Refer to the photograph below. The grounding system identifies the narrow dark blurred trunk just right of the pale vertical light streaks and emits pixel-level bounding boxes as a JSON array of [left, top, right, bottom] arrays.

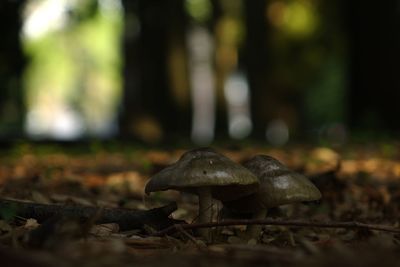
[[244, 0, 268, 137]]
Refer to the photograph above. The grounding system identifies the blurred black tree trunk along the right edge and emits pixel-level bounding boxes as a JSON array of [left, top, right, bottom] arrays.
[[347, 0, 400, 132]]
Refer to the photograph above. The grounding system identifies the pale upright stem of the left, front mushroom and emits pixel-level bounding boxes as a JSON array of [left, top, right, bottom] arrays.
[[197, 187, 212, 241]]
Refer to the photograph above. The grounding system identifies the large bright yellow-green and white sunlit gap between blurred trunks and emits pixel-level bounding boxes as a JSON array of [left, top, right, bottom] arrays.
[[22, 0, 122, 139]]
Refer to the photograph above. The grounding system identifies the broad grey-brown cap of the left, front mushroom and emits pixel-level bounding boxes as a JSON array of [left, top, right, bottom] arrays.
[[145, 148, 259, 201]]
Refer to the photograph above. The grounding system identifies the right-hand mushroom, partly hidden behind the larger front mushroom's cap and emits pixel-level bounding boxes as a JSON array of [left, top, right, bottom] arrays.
[[223, 155, 321, 238]]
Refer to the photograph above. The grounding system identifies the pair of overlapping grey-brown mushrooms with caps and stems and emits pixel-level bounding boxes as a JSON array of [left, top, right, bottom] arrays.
[[145, 148, 321, 240]]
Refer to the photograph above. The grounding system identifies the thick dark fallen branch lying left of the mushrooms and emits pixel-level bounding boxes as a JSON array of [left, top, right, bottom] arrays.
[[0, 199, 180, 231]]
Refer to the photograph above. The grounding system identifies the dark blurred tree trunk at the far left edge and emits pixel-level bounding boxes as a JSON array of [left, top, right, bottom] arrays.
[[0, 0, 25, 138]]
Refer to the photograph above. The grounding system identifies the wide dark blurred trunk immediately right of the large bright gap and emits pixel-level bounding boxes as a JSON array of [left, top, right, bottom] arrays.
[[120, 0, 182, 141]]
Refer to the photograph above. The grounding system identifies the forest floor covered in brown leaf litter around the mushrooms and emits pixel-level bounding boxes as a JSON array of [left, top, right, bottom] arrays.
[[0, 143, 400, 267]]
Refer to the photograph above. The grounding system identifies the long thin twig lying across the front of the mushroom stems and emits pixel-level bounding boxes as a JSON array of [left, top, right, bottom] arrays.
[[153, 219, 400, 236]]
